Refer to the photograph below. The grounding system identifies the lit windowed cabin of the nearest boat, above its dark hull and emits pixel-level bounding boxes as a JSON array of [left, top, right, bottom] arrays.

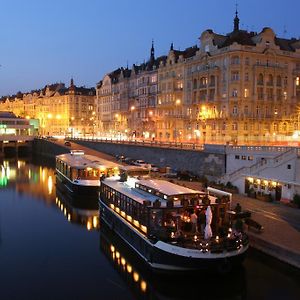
[[100, 177, 229, 241]]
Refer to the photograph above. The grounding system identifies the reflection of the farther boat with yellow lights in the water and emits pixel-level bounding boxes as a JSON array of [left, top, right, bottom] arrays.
[[55, 180, 99, 231]]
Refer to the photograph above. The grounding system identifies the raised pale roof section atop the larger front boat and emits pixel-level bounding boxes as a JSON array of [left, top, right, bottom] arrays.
[[138, 179, 203, 196]]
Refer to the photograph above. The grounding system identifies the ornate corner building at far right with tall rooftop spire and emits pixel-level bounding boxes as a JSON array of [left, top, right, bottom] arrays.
[[185, 13, 300, 143]]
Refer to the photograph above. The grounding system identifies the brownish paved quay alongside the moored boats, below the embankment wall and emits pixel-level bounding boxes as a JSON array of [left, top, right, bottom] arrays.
[[32, 140, 300, 269]]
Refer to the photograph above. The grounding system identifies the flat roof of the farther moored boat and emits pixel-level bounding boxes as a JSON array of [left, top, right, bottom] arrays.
[[56, 153, 119, 169]]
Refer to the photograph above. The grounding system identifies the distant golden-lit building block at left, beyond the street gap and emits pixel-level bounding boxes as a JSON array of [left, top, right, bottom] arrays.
[[0, 79, 97, 136]]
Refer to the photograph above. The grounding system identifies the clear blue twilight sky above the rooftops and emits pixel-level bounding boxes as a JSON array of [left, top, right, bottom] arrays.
[[0, 0, 300, 96]]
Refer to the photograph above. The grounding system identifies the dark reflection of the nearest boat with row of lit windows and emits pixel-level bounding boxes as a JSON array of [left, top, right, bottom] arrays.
[[100, 223, 247, 299]]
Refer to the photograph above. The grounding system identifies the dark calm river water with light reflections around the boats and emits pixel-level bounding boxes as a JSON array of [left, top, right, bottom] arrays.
[[0, 159, 300, 299]]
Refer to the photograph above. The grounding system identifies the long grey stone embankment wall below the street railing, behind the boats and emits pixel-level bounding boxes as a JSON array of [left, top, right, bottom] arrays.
[[69, 140, 225, 179]]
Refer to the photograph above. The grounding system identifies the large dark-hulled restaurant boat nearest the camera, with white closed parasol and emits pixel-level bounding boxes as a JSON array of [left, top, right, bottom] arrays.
[[99, 176, 249, 272]]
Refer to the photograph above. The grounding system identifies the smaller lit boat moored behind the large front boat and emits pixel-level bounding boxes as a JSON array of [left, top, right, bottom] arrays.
[[56, 150, 119, 196]]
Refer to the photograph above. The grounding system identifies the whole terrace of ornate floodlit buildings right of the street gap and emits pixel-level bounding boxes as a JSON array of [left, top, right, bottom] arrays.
[[97, 12, 300, 144]]
